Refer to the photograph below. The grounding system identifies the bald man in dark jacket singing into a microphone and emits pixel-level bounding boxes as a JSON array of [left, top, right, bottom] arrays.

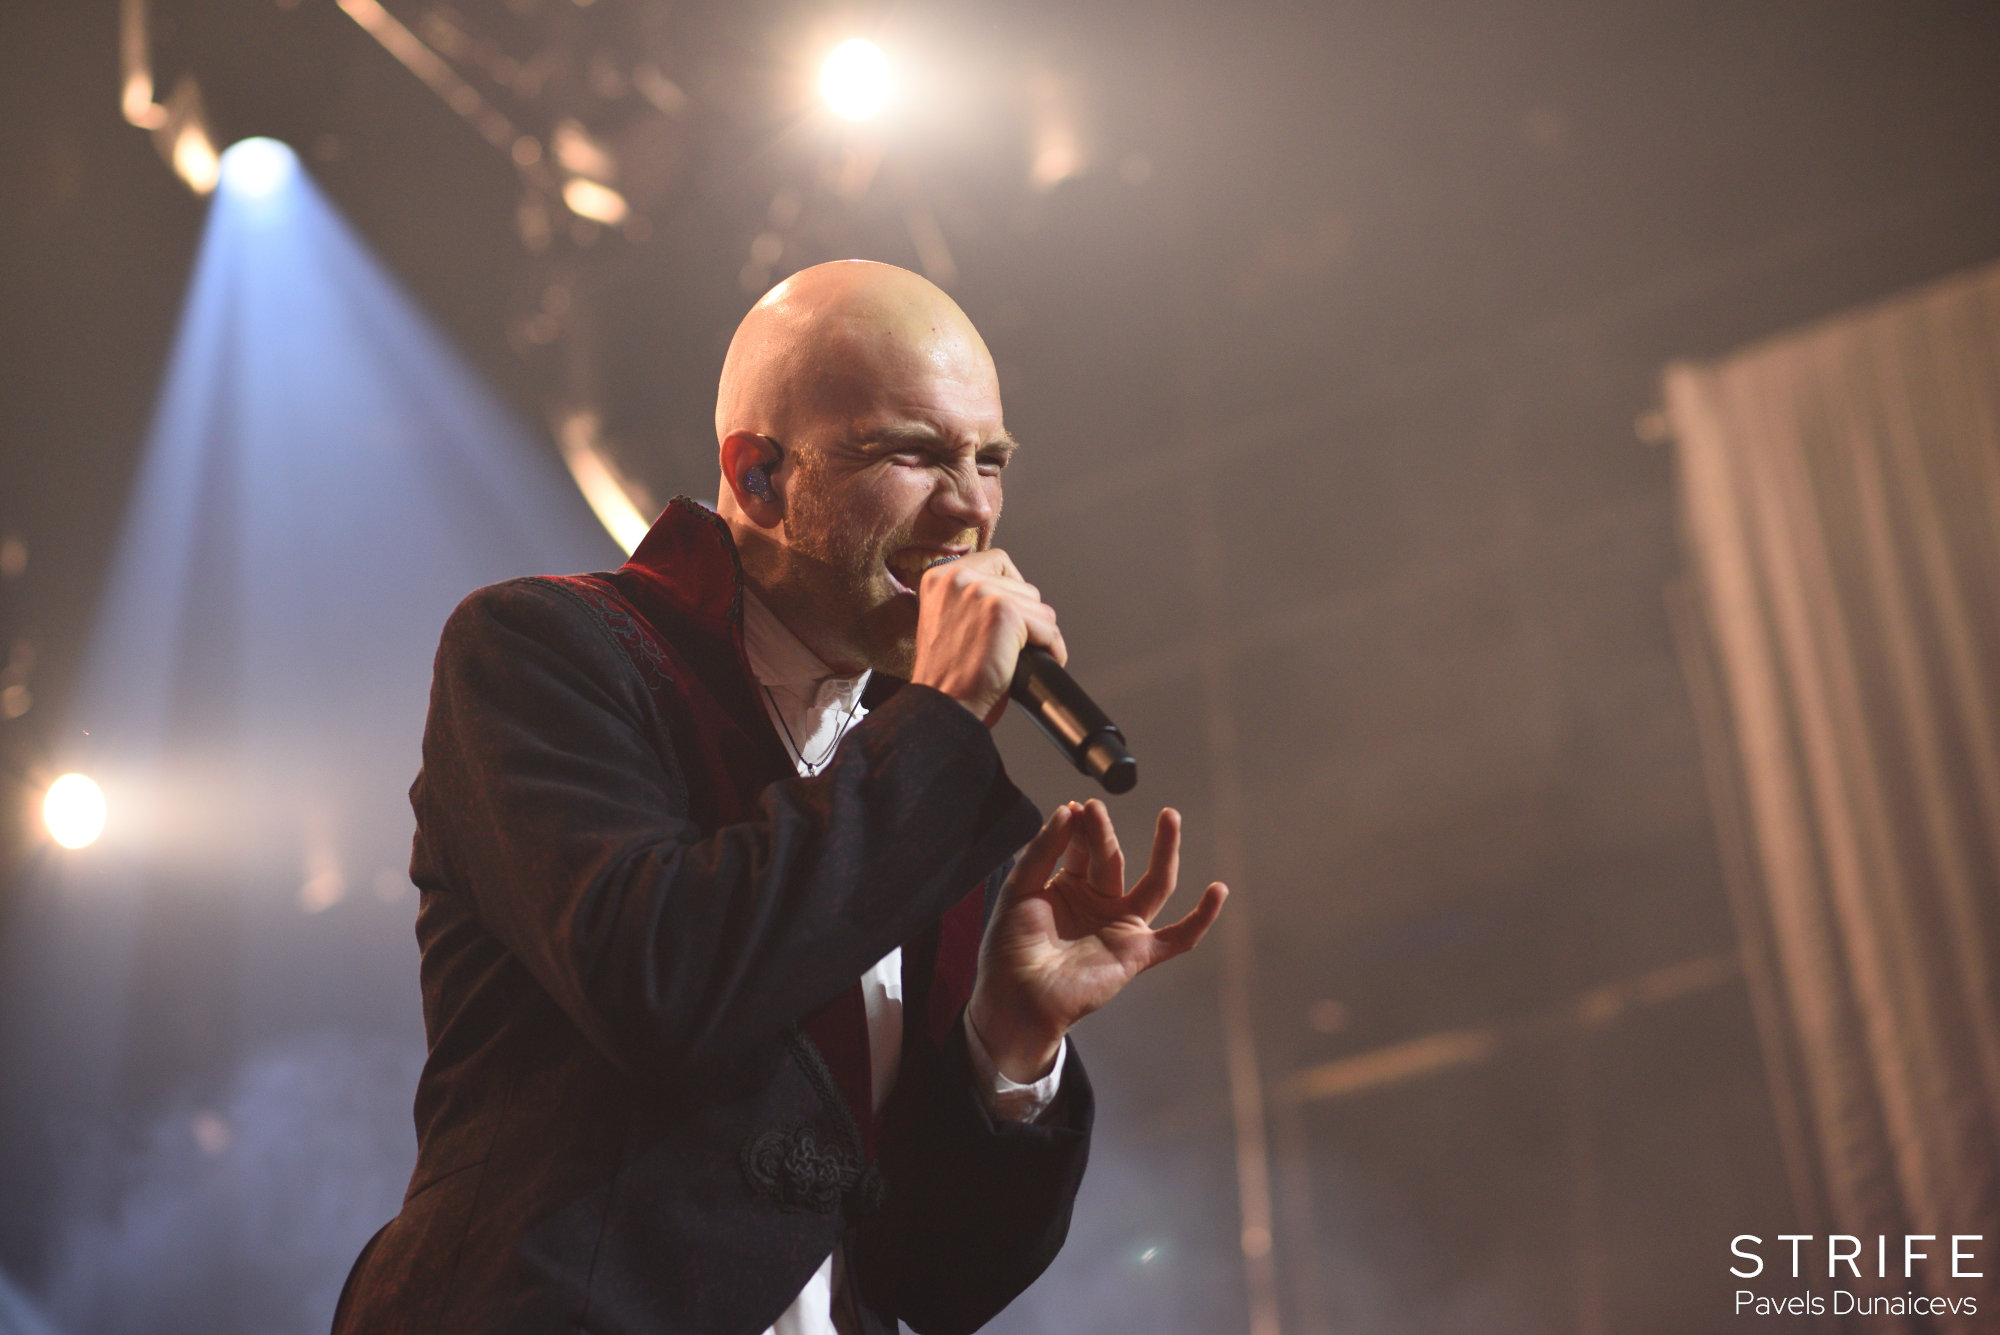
[[334, 262, 1226, 1335]]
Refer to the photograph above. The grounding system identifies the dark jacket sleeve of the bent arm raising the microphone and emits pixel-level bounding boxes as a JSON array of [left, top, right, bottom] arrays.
[[412, 580, 1036, 1075]]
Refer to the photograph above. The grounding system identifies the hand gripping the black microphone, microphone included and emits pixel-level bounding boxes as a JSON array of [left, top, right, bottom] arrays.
[[910, 548, 1138, 793]]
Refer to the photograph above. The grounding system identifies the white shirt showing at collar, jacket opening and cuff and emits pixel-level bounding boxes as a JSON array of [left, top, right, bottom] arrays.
[[744, 590, 1070, 1335]]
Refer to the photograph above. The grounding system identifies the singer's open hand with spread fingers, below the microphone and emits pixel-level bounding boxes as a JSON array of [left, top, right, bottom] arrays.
[[968, 797, 1230, 1083]]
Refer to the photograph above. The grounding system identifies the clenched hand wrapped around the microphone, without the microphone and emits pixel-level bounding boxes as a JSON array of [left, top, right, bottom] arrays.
[[910, 548, 1070, 727]]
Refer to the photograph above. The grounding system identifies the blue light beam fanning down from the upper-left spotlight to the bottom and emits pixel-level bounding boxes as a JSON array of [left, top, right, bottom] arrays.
[[0, 140, 620, 1331]]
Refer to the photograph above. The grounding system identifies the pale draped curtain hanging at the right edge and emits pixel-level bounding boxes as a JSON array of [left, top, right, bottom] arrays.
[[1666, 255, 2000, 1335]]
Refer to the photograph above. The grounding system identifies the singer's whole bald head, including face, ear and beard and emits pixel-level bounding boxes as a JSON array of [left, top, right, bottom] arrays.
[[716, 260, 1014, 675]]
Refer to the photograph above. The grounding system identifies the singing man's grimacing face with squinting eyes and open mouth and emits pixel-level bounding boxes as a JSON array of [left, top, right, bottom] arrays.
[[784, 350, 1014, 675]]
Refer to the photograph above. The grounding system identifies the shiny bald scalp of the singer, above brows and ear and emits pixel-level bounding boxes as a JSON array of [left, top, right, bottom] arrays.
[[716, 260, 1000, 442]]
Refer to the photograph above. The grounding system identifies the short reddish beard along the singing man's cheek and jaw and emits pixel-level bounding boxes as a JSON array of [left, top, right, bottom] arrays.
[[784, 450, 916, 677]]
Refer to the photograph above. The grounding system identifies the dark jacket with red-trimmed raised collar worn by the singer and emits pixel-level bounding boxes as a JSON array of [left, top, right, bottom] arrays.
[[334, 500, 1092, 1335]]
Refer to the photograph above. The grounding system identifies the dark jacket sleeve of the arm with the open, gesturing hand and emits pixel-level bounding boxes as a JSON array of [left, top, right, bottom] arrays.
[[848, 1017, 1096, 1335]]
